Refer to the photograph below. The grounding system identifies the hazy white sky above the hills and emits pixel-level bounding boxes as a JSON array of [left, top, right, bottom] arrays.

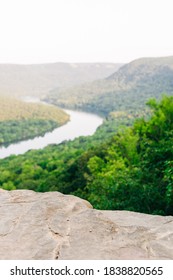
[[0, 0, 173, 63]]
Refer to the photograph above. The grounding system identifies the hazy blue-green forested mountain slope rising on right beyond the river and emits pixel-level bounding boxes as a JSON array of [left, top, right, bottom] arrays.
[[46, 57, 173, 116]]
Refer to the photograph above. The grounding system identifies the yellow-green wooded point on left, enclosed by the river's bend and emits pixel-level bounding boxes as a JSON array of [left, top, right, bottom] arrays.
[[0, 97, 69, 144]]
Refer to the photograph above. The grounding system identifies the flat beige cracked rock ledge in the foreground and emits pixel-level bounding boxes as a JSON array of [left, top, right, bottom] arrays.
[[0, 190, 173, 260]]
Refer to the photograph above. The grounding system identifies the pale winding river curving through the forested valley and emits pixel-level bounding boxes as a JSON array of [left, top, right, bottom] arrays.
[[0, 110, 103, 159]]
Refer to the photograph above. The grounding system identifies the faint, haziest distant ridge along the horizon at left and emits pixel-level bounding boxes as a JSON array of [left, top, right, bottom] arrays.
[[0, 63, 122, 97]]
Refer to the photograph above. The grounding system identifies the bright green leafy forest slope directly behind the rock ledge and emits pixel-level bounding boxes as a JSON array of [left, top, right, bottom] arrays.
[[0, 96, 173, 215]]
